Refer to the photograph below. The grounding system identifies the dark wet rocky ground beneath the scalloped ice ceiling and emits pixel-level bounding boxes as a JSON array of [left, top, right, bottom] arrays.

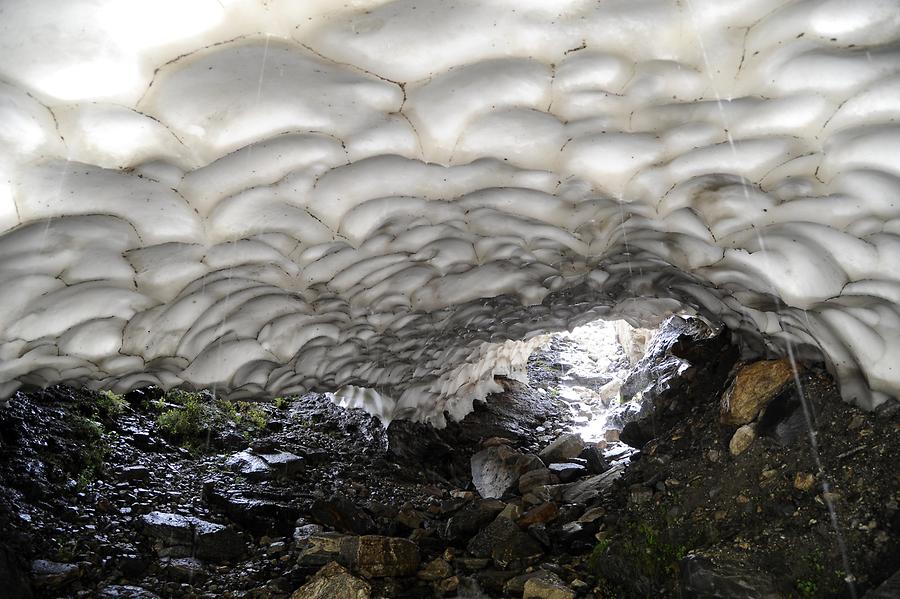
[[0, 319, 900, 599]]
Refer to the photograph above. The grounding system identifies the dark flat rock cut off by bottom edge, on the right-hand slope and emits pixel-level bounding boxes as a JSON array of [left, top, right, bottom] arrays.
[[681, 555, 781, 599]]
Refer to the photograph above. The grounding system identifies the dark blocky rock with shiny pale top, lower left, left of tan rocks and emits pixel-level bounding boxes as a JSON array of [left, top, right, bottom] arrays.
[[141, 512, 246, 562]]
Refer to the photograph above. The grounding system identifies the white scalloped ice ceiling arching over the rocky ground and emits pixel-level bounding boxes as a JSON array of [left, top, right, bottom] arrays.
[[0, 0, 900, 424]]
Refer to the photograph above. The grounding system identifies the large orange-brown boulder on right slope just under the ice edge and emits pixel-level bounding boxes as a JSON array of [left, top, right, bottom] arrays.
[[719, 358, 794, 425]]
